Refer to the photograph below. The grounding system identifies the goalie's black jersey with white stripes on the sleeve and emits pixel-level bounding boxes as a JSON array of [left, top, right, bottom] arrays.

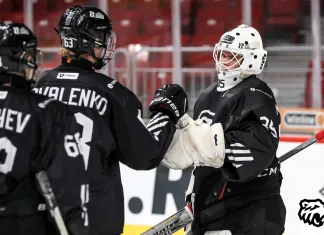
[[193, 75, 282, 231]]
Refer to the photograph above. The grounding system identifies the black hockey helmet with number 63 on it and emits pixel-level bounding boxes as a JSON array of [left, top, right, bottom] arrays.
[[58, 6, 116, 69]]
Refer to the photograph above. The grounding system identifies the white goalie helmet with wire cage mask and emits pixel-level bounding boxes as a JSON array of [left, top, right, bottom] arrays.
[[213, 24, 267, 92]]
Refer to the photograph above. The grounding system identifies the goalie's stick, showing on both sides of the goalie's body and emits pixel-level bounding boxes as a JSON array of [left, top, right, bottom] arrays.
[[141, 130, 324, 235]]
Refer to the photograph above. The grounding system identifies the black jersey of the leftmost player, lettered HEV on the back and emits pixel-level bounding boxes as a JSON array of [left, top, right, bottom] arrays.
[[0, 81, 86, 235]]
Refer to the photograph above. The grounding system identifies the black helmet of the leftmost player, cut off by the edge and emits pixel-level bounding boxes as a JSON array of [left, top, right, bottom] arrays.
[[0, 23, 41, 81]]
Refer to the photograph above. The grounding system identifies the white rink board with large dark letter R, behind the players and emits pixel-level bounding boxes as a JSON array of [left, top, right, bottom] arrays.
[[121, 142, 324, 235]]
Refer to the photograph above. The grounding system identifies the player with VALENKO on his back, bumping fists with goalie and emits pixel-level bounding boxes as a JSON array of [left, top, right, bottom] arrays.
[[34, 6, 188, 235]]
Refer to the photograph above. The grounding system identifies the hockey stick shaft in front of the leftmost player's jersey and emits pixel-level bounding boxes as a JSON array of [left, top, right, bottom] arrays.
[[36, 171, 69, 235]]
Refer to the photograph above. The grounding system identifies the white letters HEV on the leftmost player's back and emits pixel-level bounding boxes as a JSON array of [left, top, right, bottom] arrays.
[[0, 108, 31, 133]]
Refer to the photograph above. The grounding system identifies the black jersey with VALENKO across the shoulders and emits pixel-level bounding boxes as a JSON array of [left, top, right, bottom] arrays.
[[34, 59, 175, 235]]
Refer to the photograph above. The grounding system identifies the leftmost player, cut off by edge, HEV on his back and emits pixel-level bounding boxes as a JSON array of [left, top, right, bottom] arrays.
[[0, 23, 88, 235]]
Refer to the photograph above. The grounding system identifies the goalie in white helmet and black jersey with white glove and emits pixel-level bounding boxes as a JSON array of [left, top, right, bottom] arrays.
[[163, 25, 286, 235]]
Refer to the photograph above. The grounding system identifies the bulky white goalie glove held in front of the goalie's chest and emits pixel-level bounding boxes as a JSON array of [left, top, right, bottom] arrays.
[[162, 114, 225, 170]]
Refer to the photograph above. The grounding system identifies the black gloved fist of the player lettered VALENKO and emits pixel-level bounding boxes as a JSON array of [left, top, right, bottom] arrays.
[[150, 84, 188, 123]]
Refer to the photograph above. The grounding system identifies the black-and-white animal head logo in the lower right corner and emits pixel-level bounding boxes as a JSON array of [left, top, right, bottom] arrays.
[[298, 199, 324, 227]]
